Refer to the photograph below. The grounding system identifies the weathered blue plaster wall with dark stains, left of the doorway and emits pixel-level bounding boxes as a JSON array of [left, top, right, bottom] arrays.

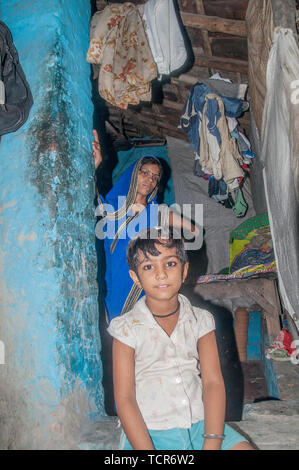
[[0, 0, 105, 449]]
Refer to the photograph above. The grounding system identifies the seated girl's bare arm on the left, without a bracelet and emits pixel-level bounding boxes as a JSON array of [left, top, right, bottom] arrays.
[[113, 339, 154, 450]]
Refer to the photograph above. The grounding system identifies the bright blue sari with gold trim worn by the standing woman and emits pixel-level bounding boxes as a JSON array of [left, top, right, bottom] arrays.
[[96, 159, 158, 322]]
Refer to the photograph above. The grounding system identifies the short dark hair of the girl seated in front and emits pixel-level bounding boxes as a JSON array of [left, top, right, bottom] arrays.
[[127, 228, 188, 273]]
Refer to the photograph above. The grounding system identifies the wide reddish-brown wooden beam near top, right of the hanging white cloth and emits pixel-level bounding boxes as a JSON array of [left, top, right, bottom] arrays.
[[181, 11, 247, 37]]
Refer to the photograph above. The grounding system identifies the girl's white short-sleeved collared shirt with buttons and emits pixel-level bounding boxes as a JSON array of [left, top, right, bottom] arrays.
[[108, 294, 215, 430]]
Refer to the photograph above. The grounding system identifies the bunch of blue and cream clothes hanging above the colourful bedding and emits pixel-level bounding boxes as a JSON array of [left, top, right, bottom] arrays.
[[179, 74, 254, 217]]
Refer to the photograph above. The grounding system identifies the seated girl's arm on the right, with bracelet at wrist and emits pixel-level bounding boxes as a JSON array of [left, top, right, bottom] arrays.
[[198, 331, 225, 450]]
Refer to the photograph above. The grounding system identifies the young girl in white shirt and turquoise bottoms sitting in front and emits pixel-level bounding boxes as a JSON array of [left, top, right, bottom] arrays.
[[108, 232, 252, 450]]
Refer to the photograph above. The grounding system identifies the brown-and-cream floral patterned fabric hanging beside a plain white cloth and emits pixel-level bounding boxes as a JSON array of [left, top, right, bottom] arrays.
[[86, 2, 157, 109]]
